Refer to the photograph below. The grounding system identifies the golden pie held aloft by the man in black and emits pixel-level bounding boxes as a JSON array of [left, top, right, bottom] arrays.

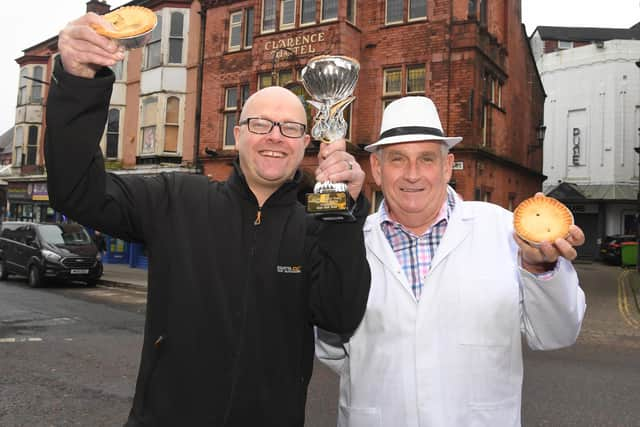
[[92, 6, 157, 39]]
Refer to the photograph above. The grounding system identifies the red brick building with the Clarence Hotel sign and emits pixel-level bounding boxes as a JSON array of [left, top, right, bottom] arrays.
[[198, 0, 545, 208]]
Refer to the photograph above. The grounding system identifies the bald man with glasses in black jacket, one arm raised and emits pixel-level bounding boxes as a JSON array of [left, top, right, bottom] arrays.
[[45, 14, 370, 427]]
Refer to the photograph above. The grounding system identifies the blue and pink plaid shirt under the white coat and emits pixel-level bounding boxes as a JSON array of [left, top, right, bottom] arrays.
[[380, 187, 456, 300]]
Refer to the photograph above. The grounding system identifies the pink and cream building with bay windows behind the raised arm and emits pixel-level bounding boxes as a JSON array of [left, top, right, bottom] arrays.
[[5, 0, 201, 264]]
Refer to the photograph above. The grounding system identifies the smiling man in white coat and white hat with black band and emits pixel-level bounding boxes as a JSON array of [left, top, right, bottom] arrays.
[[316, 97, 585, 427]]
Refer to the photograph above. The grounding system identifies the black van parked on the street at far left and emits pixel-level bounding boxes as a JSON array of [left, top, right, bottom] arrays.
[[0, 221, 102, 288]]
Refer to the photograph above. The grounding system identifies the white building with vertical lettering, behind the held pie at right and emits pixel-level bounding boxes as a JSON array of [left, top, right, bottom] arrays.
[[530, 25, 640, 258]]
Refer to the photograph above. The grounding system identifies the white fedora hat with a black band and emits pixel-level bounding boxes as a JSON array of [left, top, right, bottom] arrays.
[[365, 96, 462, 153]]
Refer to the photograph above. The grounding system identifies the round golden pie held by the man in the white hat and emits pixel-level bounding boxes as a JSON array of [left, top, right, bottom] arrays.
[[513, 196, 573, 244]]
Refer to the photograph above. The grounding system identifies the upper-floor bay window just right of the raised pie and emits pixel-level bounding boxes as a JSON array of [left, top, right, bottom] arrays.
[[143, 8, 188, 69]]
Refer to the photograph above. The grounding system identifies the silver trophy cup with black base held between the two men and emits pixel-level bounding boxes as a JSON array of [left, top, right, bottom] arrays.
[[301, 55, 360, 221]]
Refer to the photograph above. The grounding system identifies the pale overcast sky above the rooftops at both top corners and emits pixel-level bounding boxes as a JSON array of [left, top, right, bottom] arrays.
[[0, 0, 640, 134]]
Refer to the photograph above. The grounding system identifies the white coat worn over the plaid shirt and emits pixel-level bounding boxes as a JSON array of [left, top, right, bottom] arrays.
[[316, 198, 585, 427]]
